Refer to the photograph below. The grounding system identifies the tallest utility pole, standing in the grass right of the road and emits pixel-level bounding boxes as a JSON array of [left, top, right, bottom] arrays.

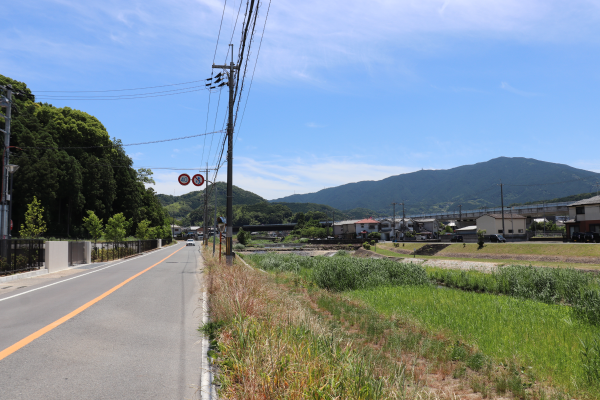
[[213, 44, 240, 265]]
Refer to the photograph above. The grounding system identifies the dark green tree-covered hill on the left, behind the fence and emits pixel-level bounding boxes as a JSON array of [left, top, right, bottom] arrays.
[[0, 75, 166, 237]]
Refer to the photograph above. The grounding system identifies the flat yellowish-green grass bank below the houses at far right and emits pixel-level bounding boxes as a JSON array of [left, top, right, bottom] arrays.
[[437, 243, 600, 257]]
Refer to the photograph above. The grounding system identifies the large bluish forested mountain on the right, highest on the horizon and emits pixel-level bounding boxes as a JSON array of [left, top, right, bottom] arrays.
[[272, 157, 600, 215]]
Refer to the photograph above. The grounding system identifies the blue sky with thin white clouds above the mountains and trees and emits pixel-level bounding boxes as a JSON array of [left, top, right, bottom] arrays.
[[0, 0, 600, 199]]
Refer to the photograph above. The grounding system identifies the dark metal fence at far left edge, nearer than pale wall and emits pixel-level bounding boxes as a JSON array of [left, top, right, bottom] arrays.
[[0, 239, 45, 275]]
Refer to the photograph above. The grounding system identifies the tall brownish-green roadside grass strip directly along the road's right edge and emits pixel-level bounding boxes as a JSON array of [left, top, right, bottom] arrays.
[[200, 252, 447, 400]]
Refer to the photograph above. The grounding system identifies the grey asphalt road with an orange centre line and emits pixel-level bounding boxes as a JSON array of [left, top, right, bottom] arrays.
[[0, 244, 202, 400]]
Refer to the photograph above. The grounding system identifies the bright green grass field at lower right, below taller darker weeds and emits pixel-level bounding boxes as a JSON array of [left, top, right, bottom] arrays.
[[348, 286, 600, 389]]
